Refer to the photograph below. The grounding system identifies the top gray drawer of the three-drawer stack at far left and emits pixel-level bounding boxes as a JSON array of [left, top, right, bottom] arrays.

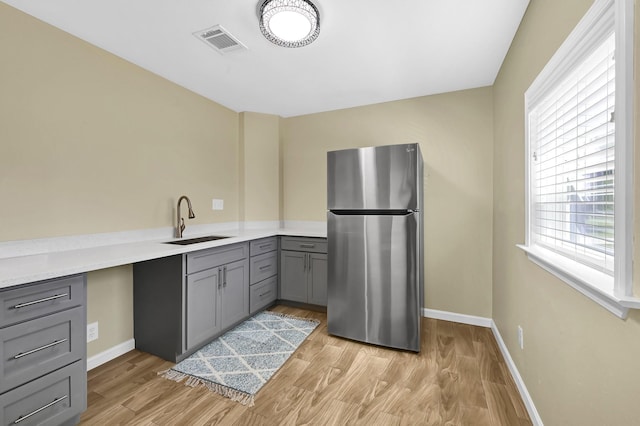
[[0, 275, 85, 327]]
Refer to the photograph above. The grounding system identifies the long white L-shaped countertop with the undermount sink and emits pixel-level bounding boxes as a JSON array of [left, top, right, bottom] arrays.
[[0, 224, 327, 289]]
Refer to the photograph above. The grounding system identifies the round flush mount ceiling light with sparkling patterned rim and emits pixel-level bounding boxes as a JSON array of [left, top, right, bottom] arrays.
[[260, 0, 320, 47]]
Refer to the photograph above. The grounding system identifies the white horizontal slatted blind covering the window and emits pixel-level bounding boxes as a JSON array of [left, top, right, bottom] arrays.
[[528, 33, 615, 275]]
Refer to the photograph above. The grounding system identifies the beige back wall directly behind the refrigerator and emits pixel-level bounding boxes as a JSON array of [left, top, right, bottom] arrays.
[[281, 88, 493, 317]]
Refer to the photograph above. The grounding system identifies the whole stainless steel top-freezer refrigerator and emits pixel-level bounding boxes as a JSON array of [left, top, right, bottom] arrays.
[[327, 144, 424, 352]]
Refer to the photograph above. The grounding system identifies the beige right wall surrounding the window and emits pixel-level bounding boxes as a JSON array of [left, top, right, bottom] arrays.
[[493, 0, 640, 425]]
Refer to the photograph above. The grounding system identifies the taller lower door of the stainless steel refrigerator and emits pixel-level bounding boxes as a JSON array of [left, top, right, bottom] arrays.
[[327, 212, 421, 352]]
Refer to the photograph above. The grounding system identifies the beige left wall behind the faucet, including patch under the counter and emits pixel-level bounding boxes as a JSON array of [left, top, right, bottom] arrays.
[[0, 3, 240, 356]]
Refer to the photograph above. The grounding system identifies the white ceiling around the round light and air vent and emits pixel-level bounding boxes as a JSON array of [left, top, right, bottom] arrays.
[[2, 0, 529, 117]]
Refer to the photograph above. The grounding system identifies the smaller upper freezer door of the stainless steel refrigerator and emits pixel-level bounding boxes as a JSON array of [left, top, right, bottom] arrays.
[[327, 144, 422, 210]]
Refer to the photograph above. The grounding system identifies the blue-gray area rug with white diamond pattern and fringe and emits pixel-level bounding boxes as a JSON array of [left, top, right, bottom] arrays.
[[158, 311, 319, 406]]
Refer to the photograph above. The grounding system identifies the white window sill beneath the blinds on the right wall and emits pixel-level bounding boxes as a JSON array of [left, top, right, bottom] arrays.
[[517, 244, 640, 319]]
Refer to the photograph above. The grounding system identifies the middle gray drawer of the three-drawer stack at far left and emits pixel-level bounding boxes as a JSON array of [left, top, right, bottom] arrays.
[[0, 307, 86, 393]]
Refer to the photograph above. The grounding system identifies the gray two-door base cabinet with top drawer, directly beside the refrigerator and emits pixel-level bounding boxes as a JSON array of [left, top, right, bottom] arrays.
[[280, 237, 327, 306]]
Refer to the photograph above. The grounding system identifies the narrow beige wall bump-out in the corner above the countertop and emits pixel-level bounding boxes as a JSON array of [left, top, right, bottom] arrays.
[[240, 112, 280, 221]]
